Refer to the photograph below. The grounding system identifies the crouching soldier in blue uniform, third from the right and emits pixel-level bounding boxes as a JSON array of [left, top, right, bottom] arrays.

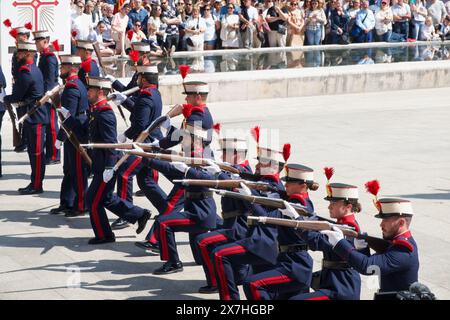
[[243, 163, 317, 300]]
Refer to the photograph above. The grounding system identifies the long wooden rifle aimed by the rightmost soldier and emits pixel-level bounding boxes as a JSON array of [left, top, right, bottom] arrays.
[[247, 216, 391, 253]]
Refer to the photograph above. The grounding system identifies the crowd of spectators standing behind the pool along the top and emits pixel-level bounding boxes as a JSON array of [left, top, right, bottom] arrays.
[[71, 0, 450, 56]]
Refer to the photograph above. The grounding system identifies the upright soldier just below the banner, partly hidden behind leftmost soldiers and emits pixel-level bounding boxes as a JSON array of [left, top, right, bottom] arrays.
[[33, 30, 61, 164]]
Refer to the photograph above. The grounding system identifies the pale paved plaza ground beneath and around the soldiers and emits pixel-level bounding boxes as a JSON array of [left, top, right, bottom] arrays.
[[0, 88, 450, 300]]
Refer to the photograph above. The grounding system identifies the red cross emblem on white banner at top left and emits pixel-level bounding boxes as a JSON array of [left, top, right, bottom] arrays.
[[12, 0, 59, 31]]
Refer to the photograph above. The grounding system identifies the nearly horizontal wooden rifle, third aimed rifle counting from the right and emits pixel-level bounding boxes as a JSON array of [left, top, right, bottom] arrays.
[[173, 179, 274, 191]]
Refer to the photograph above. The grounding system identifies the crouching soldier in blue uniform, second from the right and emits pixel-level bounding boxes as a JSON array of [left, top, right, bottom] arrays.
[[291, 183, 366, 300]]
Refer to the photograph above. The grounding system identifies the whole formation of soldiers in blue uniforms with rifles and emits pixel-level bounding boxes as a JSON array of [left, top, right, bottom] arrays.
[[0, 24, 419, 300]]
